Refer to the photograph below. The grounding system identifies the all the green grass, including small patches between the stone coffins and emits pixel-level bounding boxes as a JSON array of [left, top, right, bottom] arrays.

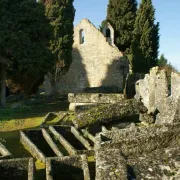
[[0, 97, 69, 180]]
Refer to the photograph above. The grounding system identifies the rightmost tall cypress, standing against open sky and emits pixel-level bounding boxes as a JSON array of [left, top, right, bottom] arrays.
[[131, 0, 159, 73]]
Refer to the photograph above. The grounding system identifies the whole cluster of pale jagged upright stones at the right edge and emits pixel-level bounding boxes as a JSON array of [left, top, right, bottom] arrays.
[[135, 67, 180, 124]]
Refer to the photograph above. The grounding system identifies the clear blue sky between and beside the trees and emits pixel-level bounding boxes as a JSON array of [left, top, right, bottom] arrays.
[[74, 0, 180, 70]]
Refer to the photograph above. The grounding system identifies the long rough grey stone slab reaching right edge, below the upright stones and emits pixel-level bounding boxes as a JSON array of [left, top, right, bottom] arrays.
[[95, 123, 180, 156]]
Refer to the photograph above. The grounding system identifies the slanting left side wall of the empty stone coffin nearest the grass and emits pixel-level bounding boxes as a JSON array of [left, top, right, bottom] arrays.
[[20, 131, 46, 162]]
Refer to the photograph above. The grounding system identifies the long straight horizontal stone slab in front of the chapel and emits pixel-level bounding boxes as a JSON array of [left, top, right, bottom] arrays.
[[68, 93, 124, 104]]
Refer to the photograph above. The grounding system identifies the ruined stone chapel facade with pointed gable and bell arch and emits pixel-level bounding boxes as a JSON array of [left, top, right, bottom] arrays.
[[45, 19, 129, 95]]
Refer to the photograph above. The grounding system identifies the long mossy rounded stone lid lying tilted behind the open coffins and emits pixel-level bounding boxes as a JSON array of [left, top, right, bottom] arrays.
[[73, 99, 147, 127]]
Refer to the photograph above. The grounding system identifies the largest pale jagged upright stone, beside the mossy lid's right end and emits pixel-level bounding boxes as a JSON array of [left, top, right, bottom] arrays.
[[135, 67, 168, 114]]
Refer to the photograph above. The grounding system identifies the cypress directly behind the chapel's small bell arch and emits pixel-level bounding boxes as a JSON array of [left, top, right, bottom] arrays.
[[107, 0, 137, 54]]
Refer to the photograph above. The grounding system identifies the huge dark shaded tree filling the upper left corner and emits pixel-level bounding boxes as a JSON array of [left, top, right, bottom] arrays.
[[0, 0, 54, 106]]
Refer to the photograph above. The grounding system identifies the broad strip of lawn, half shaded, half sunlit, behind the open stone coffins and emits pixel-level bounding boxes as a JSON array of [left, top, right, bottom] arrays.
[[0, 97, 69, 132]]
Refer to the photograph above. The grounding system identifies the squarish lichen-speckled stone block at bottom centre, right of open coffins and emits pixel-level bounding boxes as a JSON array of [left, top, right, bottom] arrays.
[[96, 149, 128, 180]]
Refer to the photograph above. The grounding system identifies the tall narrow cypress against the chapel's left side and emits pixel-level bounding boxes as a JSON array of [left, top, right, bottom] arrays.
[[42, 0, 75, 93]]
